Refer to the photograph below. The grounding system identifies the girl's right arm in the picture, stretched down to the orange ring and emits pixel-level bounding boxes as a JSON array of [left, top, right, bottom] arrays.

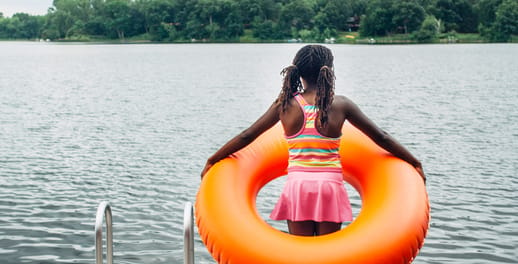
[[346, 97, 426, 181]]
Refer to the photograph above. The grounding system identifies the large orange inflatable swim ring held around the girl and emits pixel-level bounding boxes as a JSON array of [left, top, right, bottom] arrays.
[[195, 124, 429, 264]]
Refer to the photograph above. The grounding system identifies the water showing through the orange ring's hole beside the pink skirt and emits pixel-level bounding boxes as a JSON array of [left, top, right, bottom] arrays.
[[255, 176, 362, 233]]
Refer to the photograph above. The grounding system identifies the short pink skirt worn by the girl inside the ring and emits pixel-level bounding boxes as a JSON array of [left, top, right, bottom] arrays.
[[270, 171, 353, 223]]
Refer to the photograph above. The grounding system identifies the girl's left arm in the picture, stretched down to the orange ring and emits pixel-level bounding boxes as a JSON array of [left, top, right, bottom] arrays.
[[201, 101, 281, 178]]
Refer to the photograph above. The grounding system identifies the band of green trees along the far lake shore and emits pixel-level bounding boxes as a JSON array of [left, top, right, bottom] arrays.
[[0, 0, 518, 42]]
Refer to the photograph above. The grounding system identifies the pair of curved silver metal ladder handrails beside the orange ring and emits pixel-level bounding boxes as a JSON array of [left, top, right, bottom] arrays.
[[95, 202, 194, 264]]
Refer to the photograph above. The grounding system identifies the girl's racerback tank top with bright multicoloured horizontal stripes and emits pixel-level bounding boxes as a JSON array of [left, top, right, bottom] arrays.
[[286, 94, 342, 173]]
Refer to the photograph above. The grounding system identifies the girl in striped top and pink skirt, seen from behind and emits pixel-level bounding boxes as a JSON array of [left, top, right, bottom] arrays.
[[202, 45, 425, 236]]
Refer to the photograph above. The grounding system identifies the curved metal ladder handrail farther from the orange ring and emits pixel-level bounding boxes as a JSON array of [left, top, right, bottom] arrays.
[[95, 202, 113, 264]]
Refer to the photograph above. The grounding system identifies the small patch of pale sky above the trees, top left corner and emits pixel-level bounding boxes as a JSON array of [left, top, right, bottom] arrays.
[[0, 0, 53, 17]]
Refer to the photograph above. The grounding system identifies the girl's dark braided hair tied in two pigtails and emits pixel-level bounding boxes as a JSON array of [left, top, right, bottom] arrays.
[[278, 45, 335, 127]]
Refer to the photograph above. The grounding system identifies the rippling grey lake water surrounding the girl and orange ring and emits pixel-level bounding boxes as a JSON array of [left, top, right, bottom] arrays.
[[0, 42, 518, 264]]
